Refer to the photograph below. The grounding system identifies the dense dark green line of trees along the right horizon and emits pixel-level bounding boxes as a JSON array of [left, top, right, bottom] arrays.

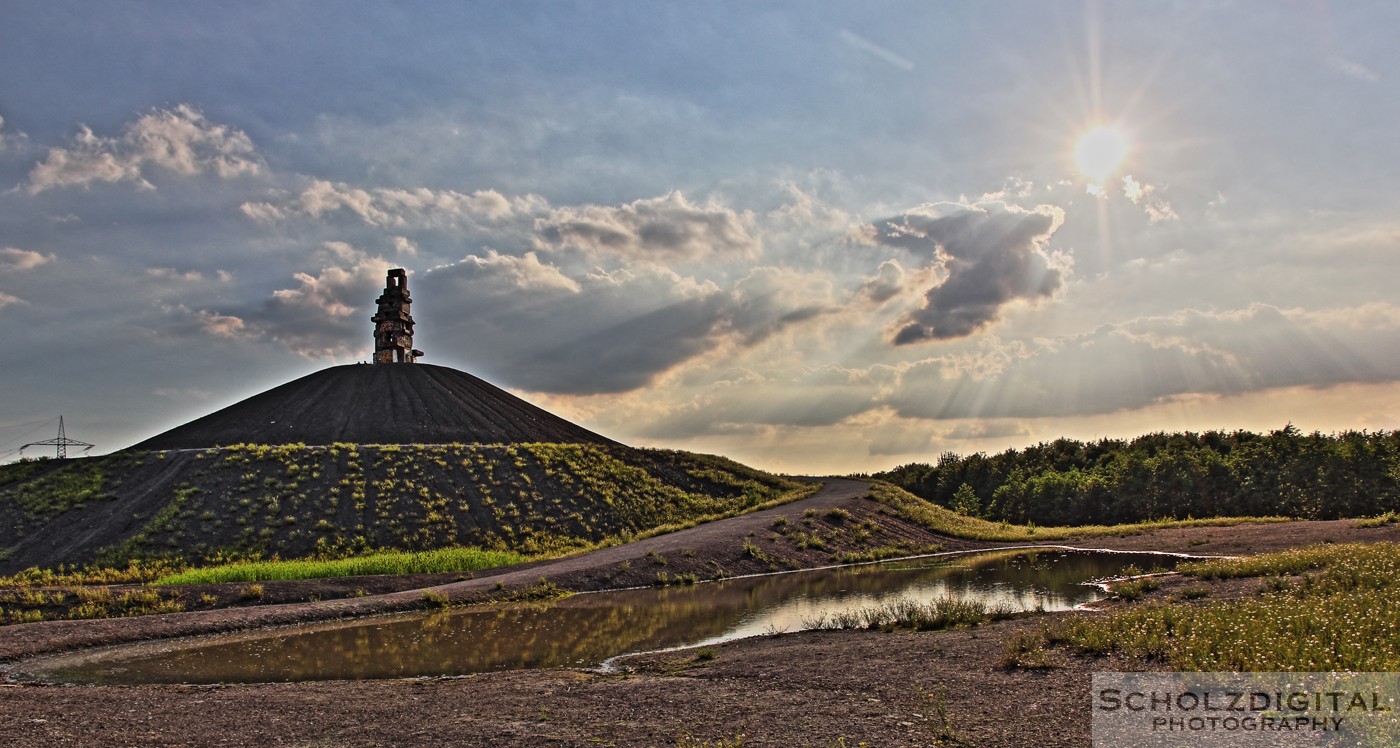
[[871, 424, 1400, 525]]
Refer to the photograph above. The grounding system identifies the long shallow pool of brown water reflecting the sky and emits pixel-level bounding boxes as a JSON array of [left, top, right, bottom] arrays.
[[17, 550, 1175, 684]]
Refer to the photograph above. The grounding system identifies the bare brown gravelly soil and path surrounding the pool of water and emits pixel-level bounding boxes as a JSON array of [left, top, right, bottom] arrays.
[[0, 479, 1400, 748]]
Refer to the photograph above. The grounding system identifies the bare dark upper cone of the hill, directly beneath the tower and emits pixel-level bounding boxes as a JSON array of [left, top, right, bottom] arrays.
[[132, 364, 613, 450]]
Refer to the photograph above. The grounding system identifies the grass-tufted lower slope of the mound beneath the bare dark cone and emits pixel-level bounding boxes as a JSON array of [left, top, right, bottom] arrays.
[[0, 444, 797, 572]]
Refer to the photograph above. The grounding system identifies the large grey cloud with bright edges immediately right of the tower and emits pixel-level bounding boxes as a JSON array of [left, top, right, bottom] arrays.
[[417, 251, 839, 395]]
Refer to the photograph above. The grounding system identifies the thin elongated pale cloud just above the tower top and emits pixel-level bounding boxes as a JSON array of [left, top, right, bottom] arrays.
[[241, 179, 547, 228]]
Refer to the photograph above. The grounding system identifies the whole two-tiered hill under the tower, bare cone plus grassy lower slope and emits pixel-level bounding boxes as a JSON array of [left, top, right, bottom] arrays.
[[0, 363, 798, 574]]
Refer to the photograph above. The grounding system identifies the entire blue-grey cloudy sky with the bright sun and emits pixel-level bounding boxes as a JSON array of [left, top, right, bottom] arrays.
[[0, 0, 1400, 473]]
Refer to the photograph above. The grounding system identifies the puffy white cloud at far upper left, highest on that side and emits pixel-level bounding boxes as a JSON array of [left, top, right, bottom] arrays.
[[28, 104, 262, 195]]
